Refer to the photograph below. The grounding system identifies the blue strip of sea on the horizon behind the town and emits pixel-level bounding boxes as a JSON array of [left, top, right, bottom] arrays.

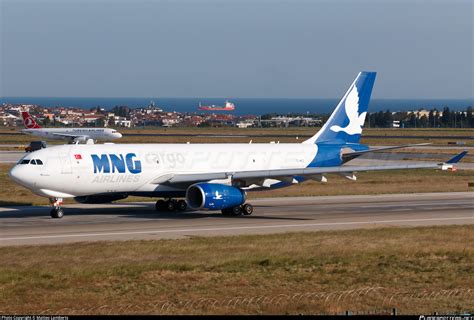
[[0, 97, 474, 116]]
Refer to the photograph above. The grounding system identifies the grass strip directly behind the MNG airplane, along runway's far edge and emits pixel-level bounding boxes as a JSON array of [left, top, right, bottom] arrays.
[[0, 164, 474, 206]]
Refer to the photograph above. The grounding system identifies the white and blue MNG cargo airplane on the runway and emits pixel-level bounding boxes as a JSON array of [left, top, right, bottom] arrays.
[[10, 72, 465, 218]]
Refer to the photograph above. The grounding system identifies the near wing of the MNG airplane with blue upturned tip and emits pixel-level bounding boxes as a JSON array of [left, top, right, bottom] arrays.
[[151, 152, 467, 184]]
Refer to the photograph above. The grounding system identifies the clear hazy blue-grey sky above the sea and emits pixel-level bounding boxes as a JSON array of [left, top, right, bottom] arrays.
[[0, 0, 474, 98]]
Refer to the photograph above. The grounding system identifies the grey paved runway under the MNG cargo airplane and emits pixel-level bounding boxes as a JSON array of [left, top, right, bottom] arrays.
[[0, 192, 474, 246]]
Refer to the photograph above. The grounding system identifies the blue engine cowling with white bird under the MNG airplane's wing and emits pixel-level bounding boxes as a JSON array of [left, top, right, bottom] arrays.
[[186, 183, 247, 210]]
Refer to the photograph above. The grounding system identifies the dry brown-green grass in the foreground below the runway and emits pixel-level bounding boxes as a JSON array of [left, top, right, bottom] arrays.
[[0, 225, 474, 314]]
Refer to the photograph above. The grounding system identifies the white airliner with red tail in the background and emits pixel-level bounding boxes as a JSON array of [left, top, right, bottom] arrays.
[[21, 111, 122, 143]]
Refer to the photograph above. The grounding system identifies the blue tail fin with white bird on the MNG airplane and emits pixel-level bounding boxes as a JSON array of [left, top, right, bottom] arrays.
[[303, 71, 376, 143]]
